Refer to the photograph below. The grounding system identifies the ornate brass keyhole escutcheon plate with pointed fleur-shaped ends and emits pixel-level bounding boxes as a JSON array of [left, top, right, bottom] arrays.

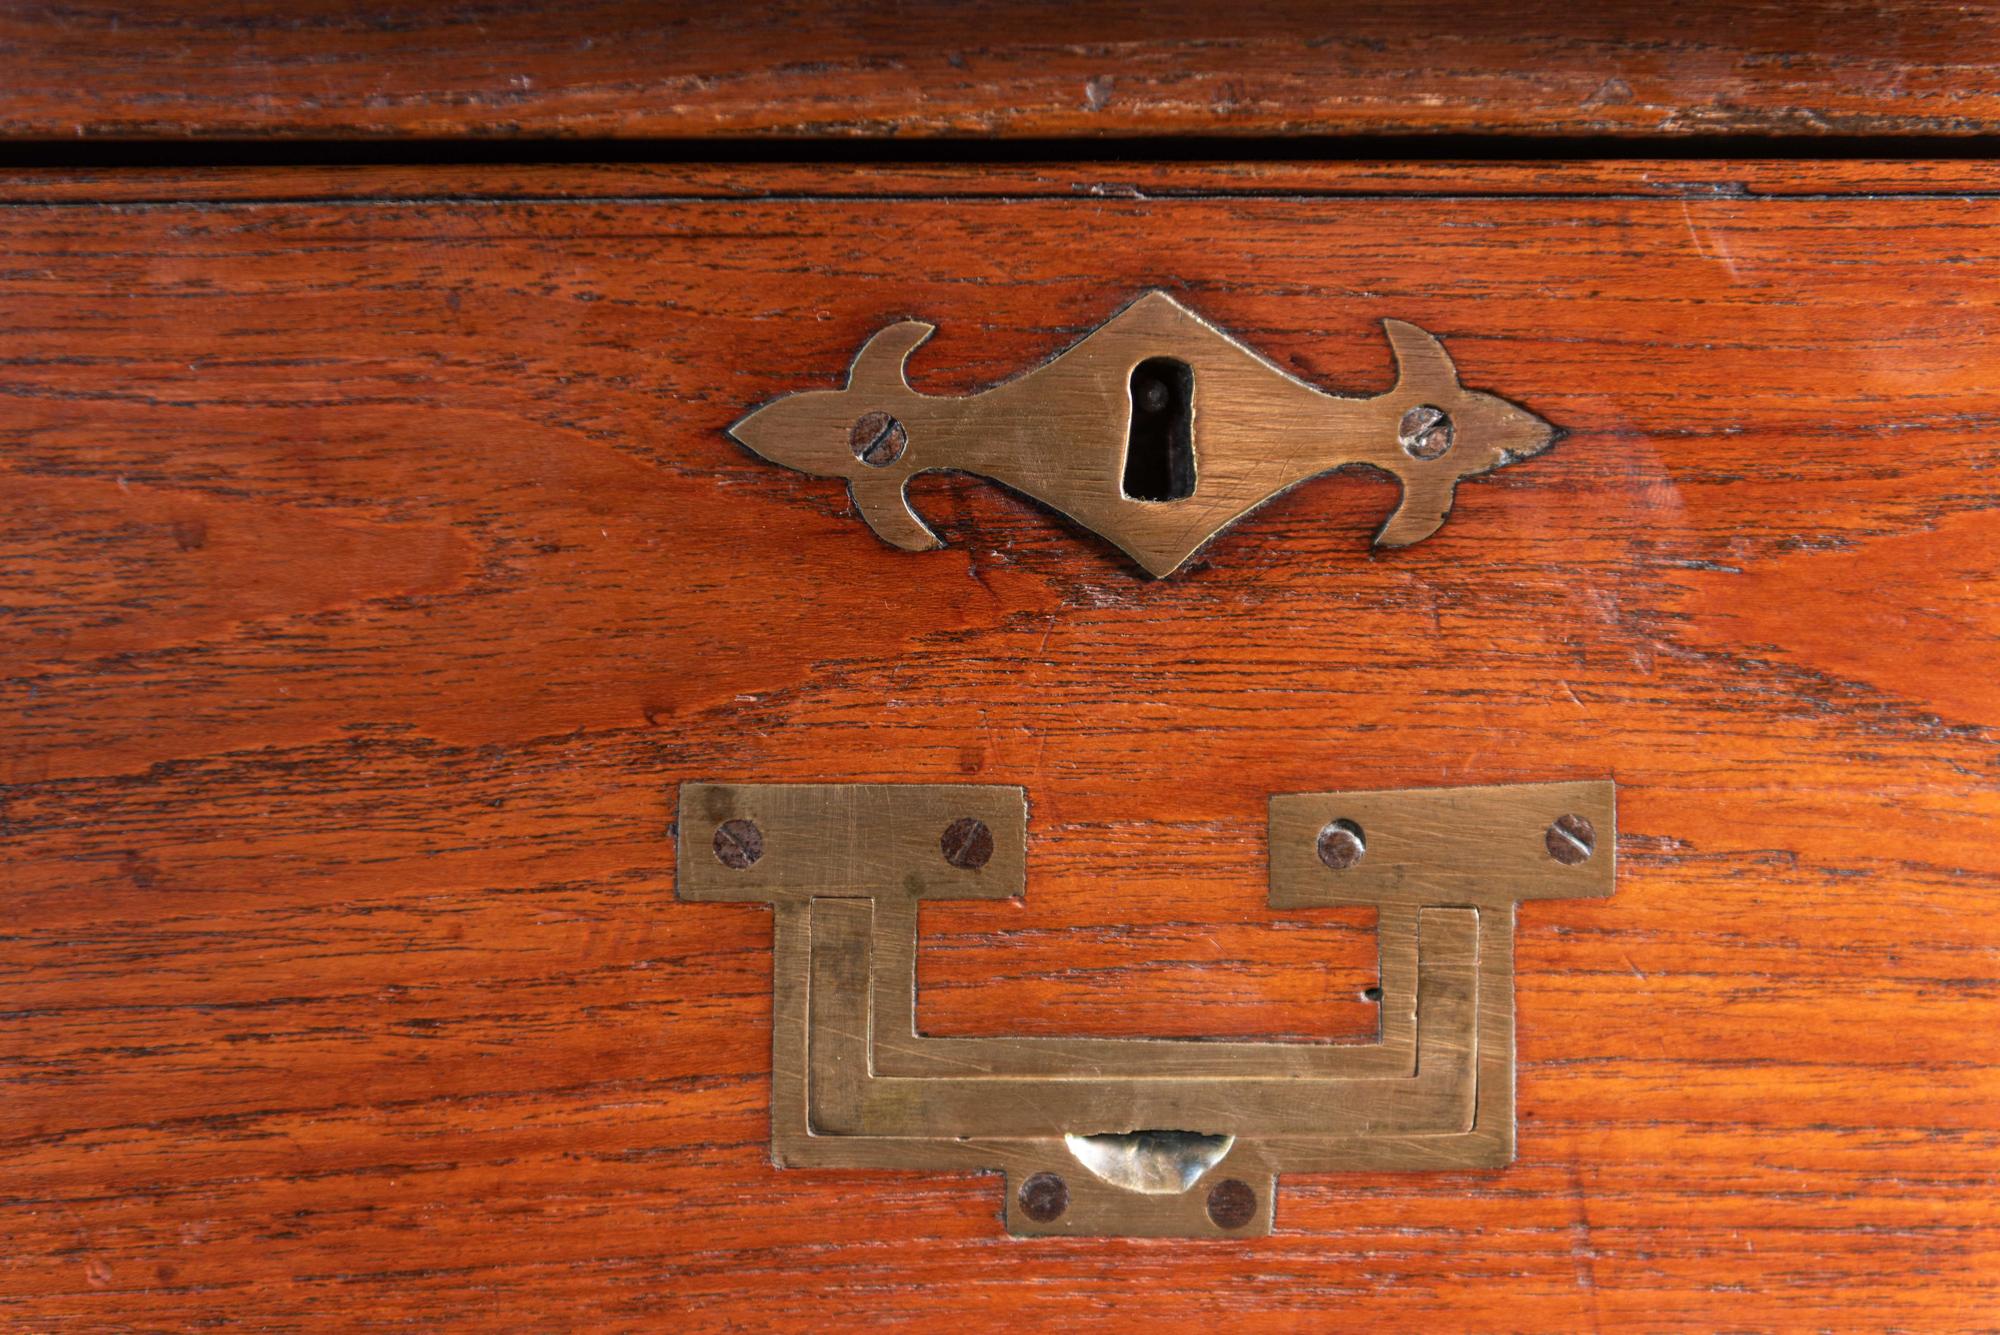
[[730, 292, 1556, 578]]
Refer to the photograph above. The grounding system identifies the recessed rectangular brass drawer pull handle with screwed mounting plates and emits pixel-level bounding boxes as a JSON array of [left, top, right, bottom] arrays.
[[678, 781, 1616, 1237]]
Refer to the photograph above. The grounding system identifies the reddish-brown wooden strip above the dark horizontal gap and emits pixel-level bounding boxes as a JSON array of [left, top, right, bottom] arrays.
[[11, 0, 2000, 144]]
